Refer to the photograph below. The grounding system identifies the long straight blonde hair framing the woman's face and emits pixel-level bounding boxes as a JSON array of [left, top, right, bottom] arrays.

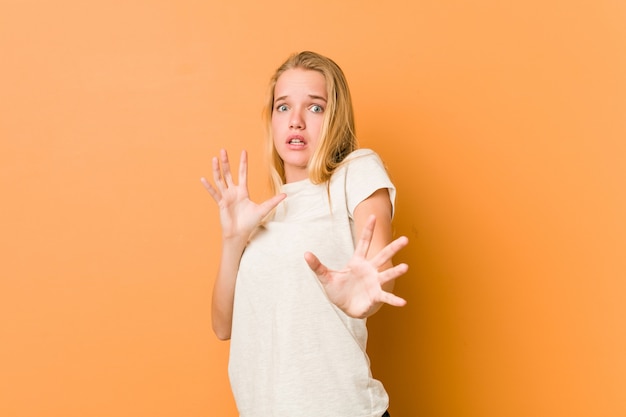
[[263, 51, 358, 193]]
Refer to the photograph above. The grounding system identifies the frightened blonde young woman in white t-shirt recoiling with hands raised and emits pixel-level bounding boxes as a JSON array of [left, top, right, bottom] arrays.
[[202, 52, 408, 417]]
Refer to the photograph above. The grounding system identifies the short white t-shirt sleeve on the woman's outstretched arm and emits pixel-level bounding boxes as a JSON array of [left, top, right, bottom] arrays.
[[345, 149, 396, 217]]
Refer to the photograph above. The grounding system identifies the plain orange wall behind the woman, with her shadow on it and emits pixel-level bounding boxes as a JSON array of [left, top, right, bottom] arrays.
[[0, 0, 626, 417]]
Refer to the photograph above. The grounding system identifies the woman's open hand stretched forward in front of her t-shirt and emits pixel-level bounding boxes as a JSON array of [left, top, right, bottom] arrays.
[[304, 216, 409, 318]]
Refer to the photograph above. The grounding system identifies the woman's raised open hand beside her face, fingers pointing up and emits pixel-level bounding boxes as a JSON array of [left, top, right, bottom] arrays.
[[200, 149, 286, 241]]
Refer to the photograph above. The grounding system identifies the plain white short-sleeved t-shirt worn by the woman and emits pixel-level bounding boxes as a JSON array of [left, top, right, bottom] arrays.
[[229, 149, 395, 417]]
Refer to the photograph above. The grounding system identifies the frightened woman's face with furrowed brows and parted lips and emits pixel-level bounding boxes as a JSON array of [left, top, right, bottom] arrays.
[[272, 68, 328, 183]]
